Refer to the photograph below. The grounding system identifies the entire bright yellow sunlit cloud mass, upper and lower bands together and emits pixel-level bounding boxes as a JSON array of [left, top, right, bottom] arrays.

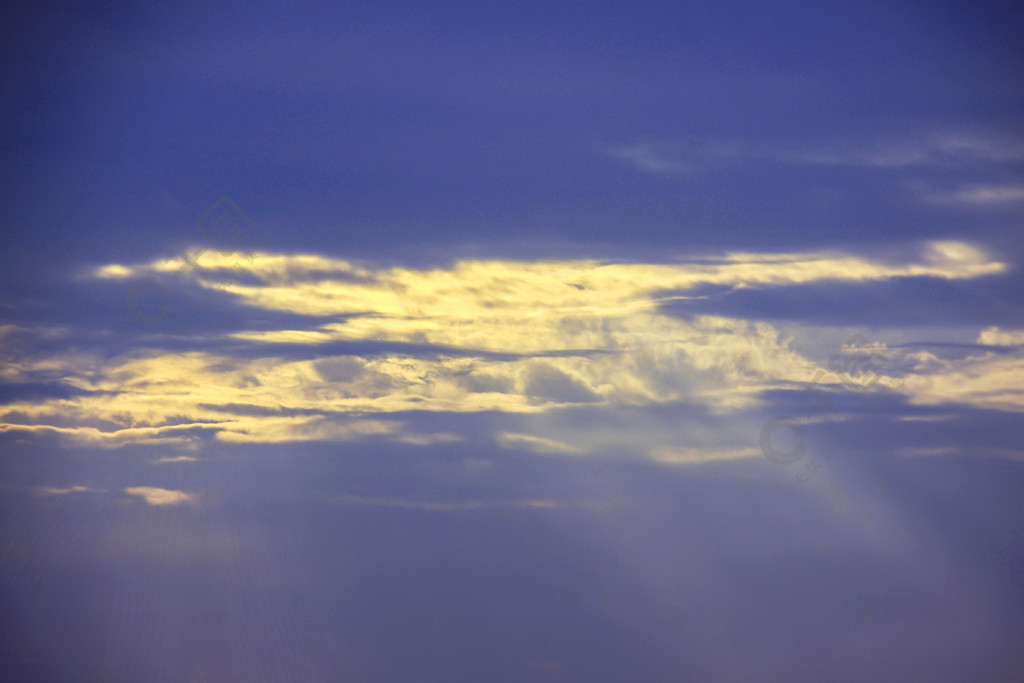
[[0, 241, 1016, 462]]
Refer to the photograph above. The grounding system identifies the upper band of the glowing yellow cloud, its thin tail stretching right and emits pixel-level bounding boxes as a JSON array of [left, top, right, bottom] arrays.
[[94, 242, 1006, 331]]
